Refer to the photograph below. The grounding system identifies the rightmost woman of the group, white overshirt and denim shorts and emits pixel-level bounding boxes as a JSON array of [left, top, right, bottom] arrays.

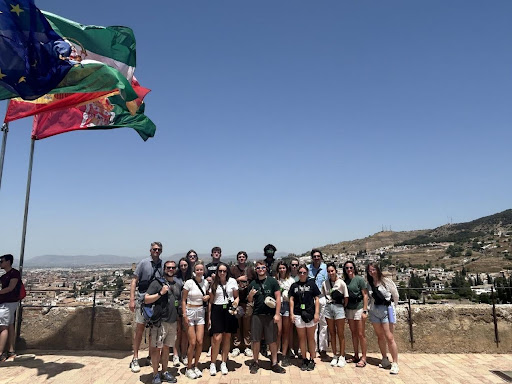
[[366, 263, 399, 375]]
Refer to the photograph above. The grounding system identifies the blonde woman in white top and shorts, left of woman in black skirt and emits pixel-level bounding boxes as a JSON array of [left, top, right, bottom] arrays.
[[181, 261, 210, 379]]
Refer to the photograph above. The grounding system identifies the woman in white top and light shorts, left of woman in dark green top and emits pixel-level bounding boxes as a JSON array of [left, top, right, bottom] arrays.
[[322, 263, 348, 368]]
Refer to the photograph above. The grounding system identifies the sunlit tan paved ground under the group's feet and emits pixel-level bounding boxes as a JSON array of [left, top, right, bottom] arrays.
[[0, 351, 512, 384]]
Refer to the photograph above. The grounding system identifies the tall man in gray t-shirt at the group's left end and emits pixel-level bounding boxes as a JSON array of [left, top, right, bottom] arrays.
[[130, 241, 163, 372]]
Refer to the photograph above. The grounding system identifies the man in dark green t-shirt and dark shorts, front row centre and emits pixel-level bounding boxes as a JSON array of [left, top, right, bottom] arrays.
[[247, 260, 286, 374]]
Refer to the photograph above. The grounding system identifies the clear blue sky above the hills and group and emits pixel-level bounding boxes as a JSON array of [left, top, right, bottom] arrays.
[[0, 0, 512, 257]]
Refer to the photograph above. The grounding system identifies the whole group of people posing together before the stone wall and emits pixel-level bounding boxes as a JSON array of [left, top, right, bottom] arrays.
[[130, 242, 399, 384]]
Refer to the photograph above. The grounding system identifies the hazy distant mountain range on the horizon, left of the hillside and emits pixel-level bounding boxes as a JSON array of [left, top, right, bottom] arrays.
[[24, 252, 288, 268]]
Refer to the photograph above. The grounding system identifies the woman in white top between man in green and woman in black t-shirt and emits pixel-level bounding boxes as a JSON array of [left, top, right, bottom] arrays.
[[276, 261, 295, 367]]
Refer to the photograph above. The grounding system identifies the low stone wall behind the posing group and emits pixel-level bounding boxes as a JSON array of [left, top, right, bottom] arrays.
[[19, 305, 512, 353]]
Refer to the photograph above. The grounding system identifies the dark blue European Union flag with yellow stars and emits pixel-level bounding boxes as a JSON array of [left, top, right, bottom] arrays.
[[0, 0, 72, 100]]
